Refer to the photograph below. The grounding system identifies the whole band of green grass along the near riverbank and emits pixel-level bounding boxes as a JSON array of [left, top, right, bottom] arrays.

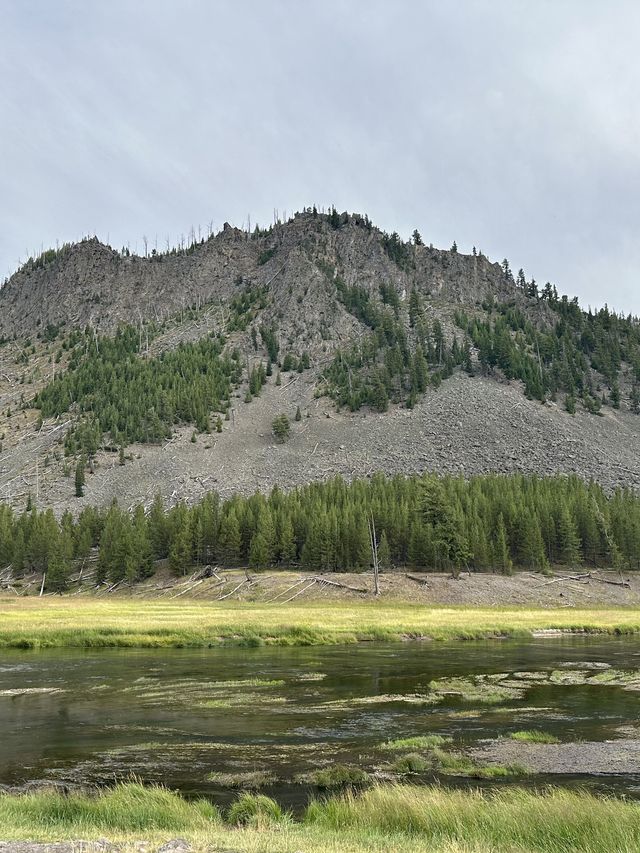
[[0, 784, 640, 853]]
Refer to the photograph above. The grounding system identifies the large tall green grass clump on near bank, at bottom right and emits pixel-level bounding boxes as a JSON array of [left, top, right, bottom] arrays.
[[305, 785, 640, 853]]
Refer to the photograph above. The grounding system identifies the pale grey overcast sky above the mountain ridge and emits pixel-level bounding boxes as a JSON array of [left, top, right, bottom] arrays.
[[0, 0, 640, 314]]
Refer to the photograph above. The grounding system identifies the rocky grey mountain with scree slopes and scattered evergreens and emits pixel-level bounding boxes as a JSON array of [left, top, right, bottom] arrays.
[[0, 209, 640, 511]]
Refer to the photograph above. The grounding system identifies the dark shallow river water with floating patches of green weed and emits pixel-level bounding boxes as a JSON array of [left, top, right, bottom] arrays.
[[0, 637, 640, 806]]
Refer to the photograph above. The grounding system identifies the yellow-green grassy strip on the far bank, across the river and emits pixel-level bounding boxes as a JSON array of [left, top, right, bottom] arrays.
[[0, 597, 640, 648]]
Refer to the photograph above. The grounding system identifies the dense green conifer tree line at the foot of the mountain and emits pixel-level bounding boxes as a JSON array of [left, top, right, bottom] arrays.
[[0, 474, 640, 591]]
